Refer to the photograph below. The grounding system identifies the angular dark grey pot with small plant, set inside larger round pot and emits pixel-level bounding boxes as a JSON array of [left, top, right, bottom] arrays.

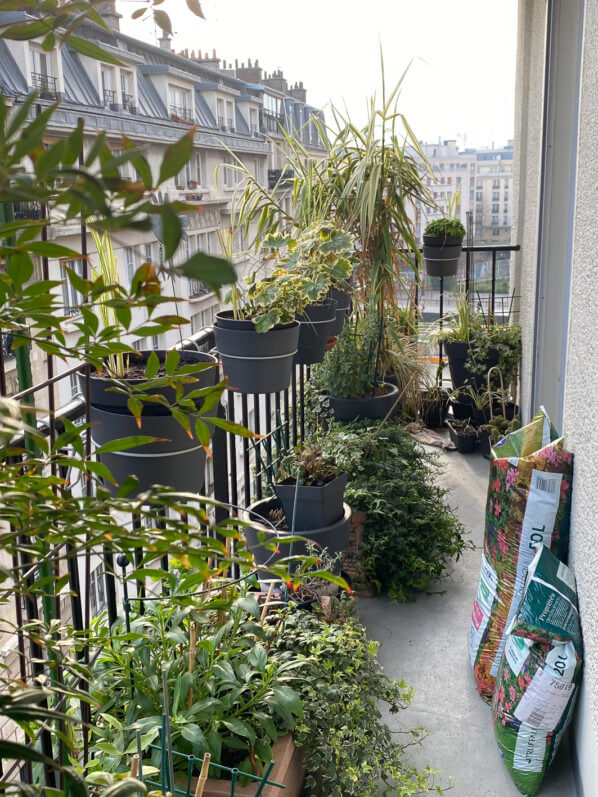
[[274, 439, 347, 531]]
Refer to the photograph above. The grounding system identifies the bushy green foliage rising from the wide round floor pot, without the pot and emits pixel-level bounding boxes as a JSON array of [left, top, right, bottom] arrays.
[[314, 315, 380, 398]]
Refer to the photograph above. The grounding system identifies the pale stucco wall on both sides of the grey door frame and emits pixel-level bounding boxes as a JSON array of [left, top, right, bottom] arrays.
[[514, 0, 598, 797]]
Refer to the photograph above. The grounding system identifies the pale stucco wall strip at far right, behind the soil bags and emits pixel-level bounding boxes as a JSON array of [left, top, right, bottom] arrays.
[[564, 0, 598, 797]]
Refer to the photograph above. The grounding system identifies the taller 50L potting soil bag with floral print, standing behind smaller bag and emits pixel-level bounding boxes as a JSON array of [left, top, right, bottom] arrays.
[[469, 410, 573, 702]]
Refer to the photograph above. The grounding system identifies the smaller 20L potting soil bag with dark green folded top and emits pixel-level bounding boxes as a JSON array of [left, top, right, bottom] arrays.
[[492, 545, 582, 797]]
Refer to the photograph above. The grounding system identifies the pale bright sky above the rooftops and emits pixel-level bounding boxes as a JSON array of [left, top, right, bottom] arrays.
[[117, 0, 517, 147]]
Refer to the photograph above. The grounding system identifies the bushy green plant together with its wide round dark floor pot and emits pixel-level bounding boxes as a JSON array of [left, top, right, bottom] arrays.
[[317, 316, 400, 421]]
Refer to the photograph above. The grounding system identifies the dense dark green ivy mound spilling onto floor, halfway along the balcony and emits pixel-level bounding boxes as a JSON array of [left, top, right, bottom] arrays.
[[325, 421, 466, 600]]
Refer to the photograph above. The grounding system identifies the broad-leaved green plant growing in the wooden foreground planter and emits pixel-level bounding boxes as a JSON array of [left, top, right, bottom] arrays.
[[90, 592, 301, 774]]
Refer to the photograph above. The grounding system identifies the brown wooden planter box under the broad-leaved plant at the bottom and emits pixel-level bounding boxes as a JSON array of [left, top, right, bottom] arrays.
[[183, 734, 305, 797]]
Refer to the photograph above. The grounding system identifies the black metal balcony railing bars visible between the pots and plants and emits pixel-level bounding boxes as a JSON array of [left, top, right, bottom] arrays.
[[0, 190, 519, 786]]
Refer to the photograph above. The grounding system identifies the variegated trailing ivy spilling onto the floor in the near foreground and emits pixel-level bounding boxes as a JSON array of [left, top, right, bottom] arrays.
[[272, 611, 441, 797]]
